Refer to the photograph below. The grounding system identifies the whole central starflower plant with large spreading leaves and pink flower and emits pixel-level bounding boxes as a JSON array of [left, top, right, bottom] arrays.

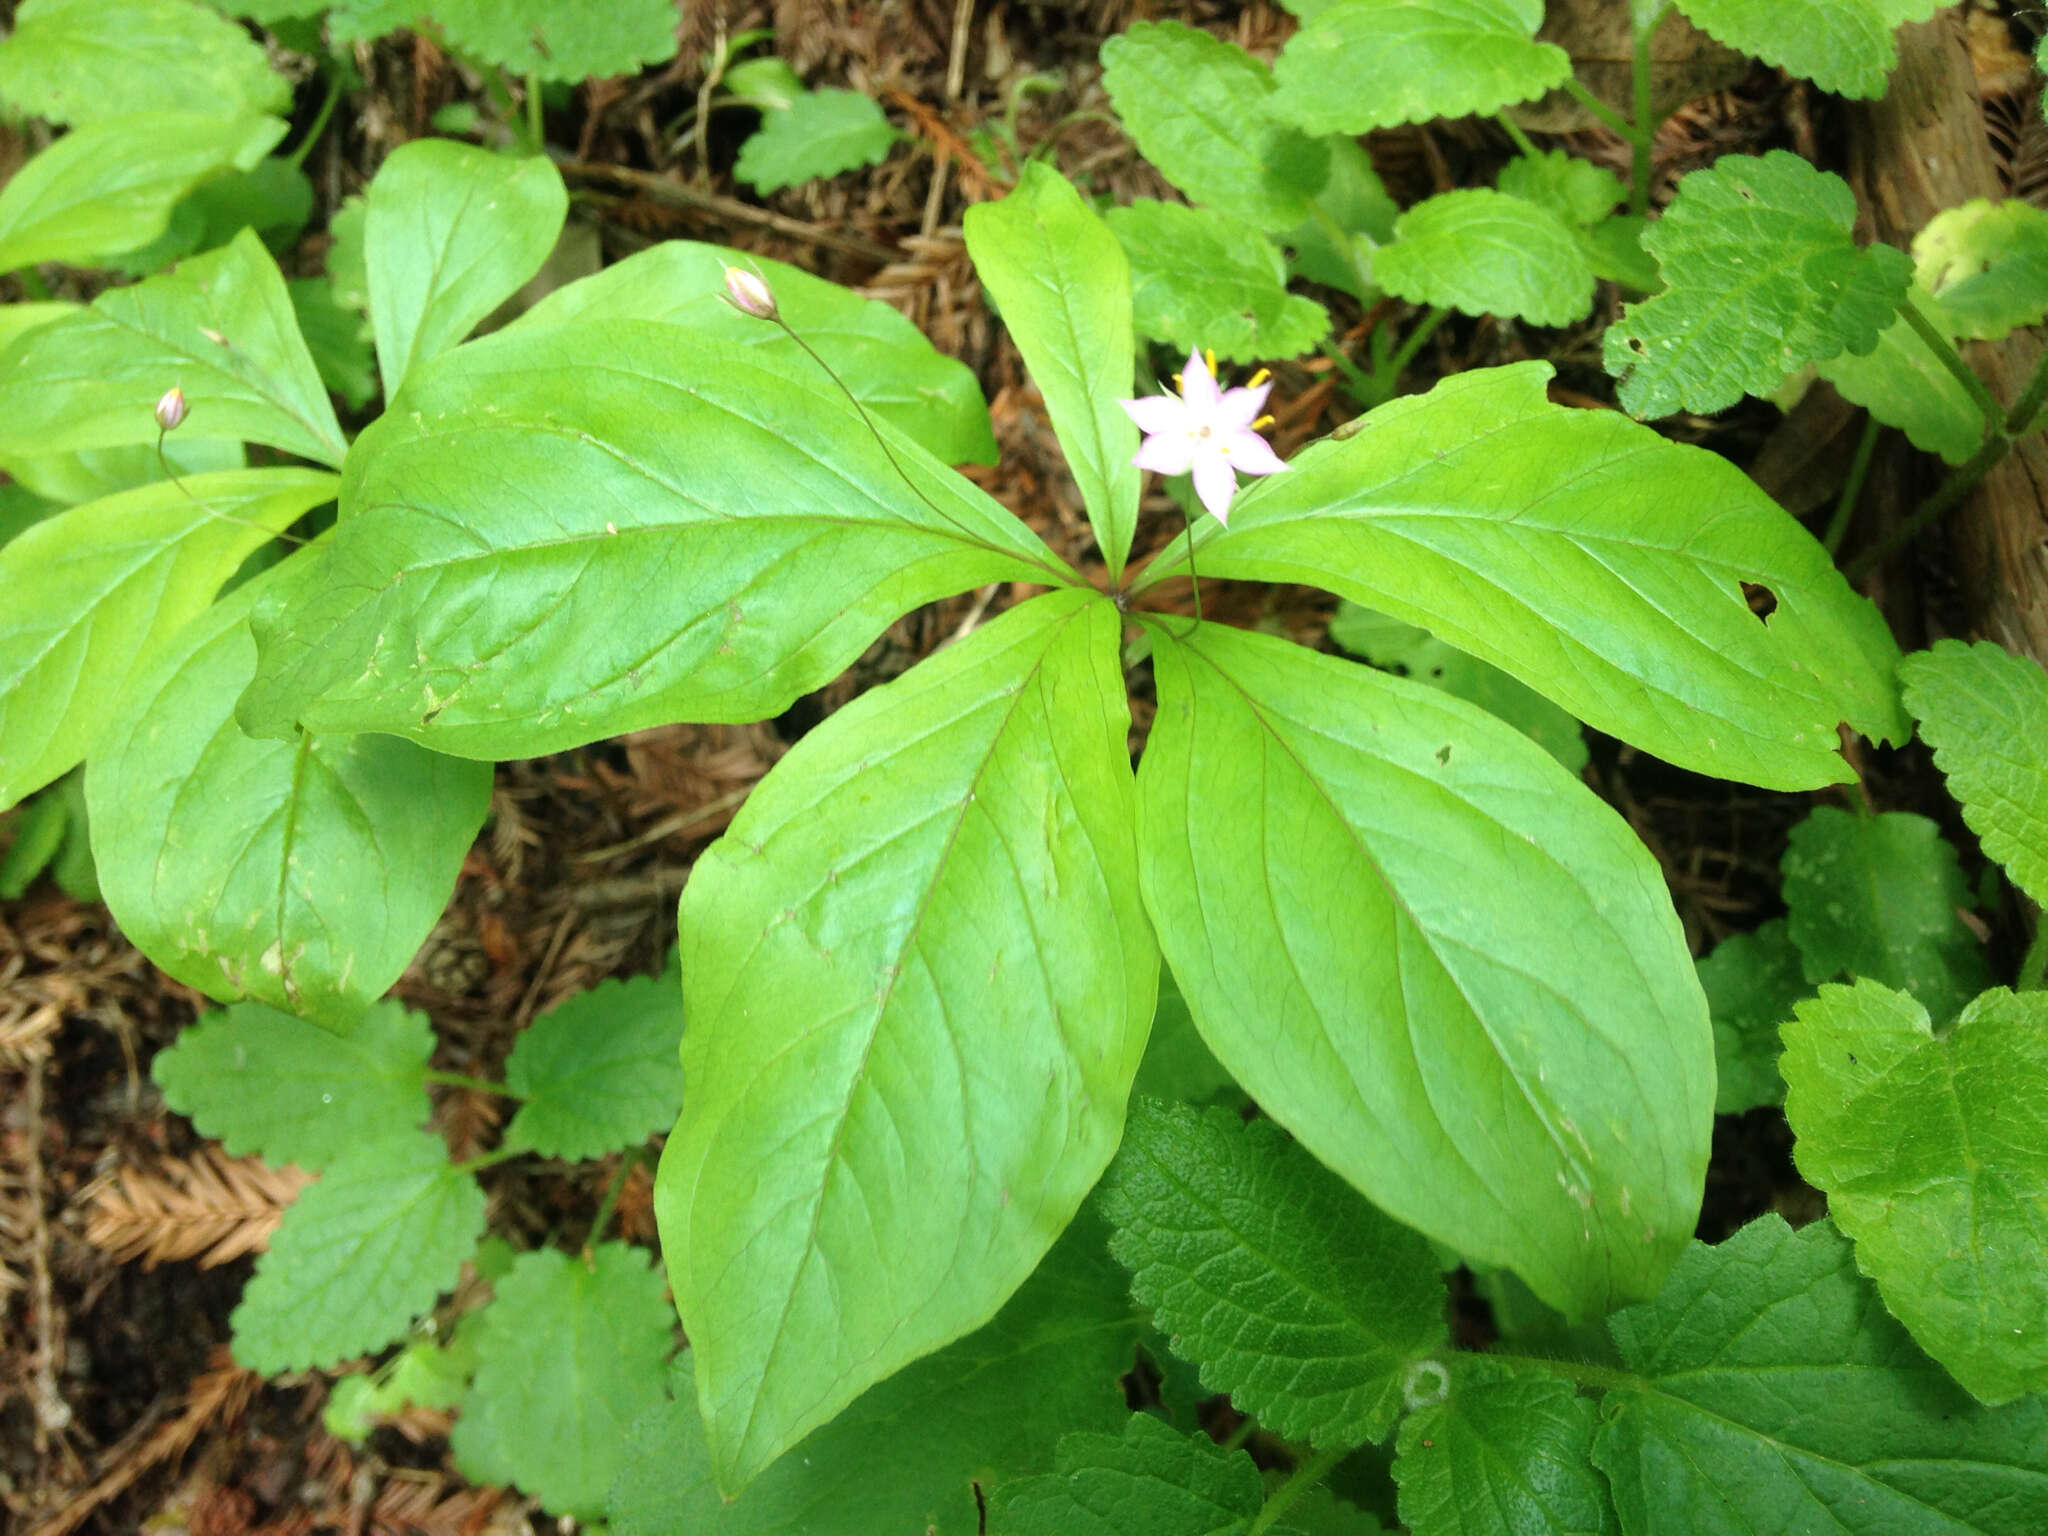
[[240, 164, 1905, 1493]]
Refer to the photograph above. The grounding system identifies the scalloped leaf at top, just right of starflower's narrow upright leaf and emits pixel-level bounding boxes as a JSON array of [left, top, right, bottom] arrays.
[[1102, 20, 1331, 233]]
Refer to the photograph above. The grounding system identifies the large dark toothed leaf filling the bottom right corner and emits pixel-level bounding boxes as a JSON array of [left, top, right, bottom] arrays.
[[1593, 1217, 2048, 1536]]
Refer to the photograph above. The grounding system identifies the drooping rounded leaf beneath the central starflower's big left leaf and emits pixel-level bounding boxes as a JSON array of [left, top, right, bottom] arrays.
[[86, 561, 492, 1032]]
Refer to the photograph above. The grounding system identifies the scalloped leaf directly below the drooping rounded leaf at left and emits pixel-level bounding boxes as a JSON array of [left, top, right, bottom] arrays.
[[150, 1001, 434, 1174]]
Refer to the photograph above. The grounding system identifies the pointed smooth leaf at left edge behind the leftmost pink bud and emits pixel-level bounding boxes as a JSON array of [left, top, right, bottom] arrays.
[[0, 229, 348, 467]]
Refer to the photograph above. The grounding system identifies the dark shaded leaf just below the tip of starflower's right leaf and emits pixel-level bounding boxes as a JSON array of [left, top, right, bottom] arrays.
[[1784, 805, 1991, 1022]]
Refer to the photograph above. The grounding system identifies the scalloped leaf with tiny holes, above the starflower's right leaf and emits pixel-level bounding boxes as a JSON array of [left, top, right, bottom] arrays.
[[1602, 152, 1913, 416]]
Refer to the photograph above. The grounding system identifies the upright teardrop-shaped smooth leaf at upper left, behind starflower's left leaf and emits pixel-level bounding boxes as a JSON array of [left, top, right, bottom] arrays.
[[365, 139, 569, 399]]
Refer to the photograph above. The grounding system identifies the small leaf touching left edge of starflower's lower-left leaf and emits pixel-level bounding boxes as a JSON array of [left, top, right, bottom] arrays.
[[504, 967, 682, 1157]]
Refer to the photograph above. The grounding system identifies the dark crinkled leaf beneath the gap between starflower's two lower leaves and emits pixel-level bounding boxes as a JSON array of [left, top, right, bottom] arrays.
[[1102, 1100, 1448, 1446]]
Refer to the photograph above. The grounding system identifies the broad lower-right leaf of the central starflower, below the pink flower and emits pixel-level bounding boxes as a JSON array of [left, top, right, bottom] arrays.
[[1139, 623, 1714, 1315]]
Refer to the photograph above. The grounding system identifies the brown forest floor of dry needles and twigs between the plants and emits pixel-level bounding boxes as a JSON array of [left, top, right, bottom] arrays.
[[0, 0, 2048, 1536]]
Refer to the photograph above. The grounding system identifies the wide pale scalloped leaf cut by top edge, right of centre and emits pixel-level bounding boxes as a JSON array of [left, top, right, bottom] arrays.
[[1272, 0, 1571, 133]]
